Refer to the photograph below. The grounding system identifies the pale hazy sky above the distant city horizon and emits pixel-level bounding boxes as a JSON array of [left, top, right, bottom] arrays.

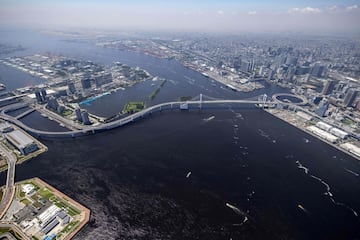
[[0, 0, 360, 33]]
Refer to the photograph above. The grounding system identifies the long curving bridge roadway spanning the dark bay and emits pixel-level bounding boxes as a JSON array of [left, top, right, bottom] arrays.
[[0, 100, 276, 138]]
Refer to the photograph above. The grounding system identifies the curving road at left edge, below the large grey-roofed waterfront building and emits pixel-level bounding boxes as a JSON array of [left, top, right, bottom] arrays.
[[0, 143, 16, 219]]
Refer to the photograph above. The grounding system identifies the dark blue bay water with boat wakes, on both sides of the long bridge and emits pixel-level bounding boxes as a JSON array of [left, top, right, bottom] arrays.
[[0, 29, 360, 240]]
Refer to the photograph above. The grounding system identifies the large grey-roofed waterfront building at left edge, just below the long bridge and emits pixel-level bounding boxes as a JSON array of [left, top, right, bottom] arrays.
[[5, 130, 39, 155]]
